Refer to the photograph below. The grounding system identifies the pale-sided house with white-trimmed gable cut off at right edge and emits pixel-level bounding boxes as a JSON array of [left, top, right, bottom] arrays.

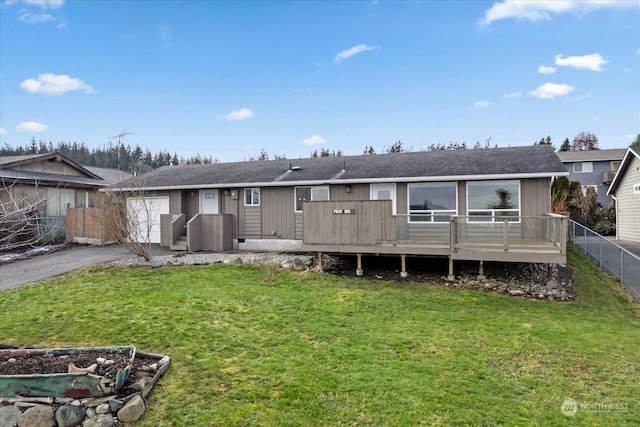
[[608, 146, 640, 243]]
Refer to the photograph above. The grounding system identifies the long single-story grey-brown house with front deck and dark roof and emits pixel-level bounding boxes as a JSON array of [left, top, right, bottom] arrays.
[[116, 146, 568, 274]]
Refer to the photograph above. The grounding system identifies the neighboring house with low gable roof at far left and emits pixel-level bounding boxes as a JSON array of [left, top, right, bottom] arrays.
[[0, 153, 131, 241]]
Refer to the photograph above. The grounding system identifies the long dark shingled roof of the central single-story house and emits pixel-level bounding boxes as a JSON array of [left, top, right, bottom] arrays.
[[116, 146, 568, 190]]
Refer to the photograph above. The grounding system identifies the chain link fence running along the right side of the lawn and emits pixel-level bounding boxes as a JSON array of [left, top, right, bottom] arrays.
[[569, 221, 640, 298]]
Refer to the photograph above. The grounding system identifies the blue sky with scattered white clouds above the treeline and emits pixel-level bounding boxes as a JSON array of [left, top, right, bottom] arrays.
[[0, 0, 640, 161]]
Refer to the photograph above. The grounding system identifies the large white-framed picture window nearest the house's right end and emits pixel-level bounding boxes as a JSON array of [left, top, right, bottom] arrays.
[[467, 180, 520, 222]]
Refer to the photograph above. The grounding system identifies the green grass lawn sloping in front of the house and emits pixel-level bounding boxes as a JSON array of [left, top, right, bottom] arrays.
[[0, 246, 640, 427]]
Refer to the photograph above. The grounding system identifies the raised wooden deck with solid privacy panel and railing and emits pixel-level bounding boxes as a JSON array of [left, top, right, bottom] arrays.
[[302, 201, 567, 264]]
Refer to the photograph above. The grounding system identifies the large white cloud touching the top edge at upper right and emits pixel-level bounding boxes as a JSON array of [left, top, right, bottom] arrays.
[[480, 0, 638, 25]]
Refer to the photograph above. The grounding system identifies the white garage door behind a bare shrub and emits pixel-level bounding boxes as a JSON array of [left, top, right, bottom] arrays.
[[127, 197, 169, 243]]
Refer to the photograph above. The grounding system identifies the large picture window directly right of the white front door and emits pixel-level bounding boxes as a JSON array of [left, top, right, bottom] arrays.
[[407, 182, 458, 222]]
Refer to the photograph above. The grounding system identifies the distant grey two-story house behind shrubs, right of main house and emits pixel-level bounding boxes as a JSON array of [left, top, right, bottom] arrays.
[[557, 148, 627, 208]]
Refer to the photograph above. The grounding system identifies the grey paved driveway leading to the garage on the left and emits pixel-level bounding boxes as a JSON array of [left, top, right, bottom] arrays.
[[0, 245, 159, 291]]
